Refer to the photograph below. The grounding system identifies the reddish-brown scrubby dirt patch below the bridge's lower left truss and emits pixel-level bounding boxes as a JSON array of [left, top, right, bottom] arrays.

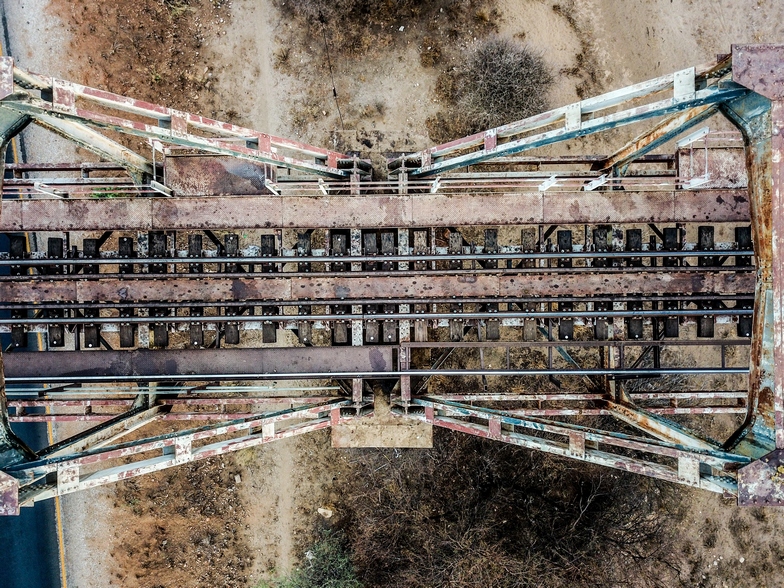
[[112, 459, 253, 588]]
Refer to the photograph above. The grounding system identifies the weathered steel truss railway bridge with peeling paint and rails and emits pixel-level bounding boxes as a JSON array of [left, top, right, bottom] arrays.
[[0, 45, 784, 515]]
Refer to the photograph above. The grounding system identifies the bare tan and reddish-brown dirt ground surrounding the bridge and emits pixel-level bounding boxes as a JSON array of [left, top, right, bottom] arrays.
[[6, 0, 784, 588]]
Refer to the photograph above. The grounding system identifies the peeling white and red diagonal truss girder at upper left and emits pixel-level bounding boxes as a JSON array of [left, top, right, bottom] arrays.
[[0, 57, 352, 178]]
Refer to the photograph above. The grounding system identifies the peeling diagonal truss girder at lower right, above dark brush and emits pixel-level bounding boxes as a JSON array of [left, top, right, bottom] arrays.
[[408, 397, 751, 494]]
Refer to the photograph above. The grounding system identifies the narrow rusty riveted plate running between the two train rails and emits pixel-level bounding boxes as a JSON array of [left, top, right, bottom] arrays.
[[0, 271, 754, 304]]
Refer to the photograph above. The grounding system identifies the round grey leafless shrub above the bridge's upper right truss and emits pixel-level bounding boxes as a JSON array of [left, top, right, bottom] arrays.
[[427, 38, 553, 143]]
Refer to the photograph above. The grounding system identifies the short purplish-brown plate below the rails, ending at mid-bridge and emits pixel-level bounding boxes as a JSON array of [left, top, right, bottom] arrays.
[[5, 347, 394, 382]]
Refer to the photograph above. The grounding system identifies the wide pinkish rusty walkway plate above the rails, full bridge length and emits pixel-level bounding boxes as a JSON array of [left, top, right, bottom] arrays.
[[0, 189, 749, 232]]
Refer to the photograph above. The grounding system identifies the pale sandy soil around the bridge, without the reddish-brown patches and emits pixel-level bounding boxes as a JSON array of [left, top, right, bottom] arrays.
[[5, 0, 784, 588]]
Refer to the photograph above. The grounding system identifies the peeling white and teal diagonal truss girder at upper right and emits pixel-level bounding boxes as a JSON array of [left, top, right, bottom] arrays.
[[389, 58, 748, 177]]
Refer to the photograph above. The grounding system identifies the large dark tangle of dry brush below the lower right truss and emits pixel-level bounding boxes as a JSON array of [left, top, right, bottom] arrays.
[[338, 431, 674, 588]]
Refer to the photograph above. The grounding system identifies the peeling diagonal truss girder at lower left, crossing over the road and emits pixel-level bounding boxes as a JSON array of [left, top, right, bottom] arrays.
[[0, 400, 351, 514]]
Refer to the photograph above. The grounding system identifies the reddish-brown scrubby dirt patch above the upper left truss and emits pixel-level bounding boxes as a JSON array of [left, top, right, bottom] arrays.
[[50, 0, 231, 115]]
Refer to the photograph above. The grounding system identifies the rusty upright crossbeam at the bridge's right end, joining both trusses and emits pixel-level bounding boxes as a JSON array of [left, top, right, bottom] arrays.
[[722, 45, 784, 468]]
